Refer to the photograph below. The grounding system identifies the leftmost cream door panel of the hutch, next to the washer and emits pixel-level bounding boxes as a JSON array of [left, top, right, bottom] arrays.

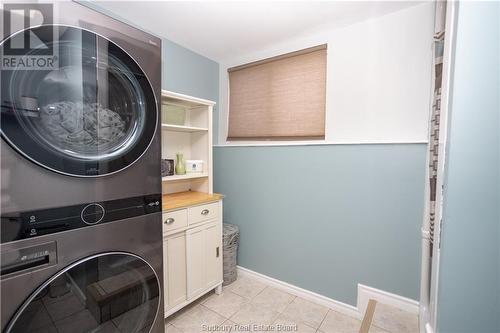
[[163, 233, 187, 308]]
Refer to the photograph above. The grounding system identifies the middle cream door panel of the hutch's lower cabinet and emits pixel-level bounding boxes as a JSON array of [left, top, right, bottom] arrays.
[[186, 226, 206, 299]]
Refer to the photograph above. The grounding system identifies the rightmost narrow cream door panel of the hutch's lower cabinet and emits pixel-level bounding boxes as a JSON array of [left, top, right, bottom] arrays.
[[205, 223, 222, 287]]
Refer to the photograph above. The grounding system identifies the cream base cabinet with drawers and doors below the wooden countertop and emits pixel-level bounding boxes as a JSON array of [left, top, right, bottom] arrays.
[[163, 200, 223, 317]]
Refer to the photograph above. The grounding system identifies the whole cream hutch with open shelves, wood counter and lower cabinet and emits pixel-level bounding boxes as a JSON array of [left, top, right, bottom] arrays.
[[161, 91, 223, 317]]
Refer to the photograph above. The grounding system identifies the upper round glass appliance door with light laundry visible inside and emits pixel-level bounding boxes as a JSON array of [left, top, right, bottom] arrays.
[[0, 26, 158, 177]]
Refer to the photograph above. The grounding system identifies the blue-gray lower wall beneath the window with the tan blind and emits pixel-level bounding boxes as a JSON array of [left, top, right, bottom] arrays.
[[214, 144, 426, 306]]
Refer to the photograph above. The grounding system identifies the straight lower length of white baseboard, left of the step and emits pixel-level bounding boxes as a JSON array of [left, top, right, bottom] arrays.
[[238, 266, 361, 319]]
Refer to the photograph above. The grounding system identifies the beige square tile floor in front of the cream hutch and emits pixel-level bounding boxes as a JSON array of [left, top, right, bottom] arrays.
[[165, 277, 418, 333]]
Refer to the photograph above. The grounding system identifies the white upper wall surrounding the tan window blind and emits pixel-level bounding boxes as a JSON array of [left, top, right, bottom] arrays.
[[219, 2, 434, 144]]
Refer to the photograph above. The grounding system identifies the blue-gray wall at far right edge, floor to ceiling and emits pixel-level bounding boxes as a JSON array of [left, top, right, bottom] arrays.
[[437, 2, 500, 333]]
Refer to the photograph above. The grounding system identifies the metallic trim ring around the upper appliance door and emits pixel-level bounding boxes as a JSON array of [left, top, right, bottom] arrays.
[[0, 23, 159, 178]]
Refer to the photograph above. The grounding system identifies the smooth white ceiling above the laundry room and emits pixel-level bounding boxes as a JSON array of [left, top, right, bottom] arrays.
[[94, 0, 421, 62]]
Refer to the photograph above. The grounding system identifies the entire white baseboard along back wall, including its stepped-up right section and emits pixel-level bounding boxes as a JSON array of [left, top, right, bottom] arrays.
[[237, 266, 419, 319]]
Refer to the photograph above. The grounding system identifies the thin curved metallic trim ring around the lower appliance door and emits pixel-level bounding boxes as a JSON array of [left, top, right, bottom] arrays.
[[5, 251, 162, 333]]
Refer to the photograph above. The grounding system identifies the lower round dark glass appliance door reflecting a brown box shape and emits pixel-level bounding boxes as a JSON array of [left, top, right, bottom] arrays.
[[6, 253, 160, 333]]
